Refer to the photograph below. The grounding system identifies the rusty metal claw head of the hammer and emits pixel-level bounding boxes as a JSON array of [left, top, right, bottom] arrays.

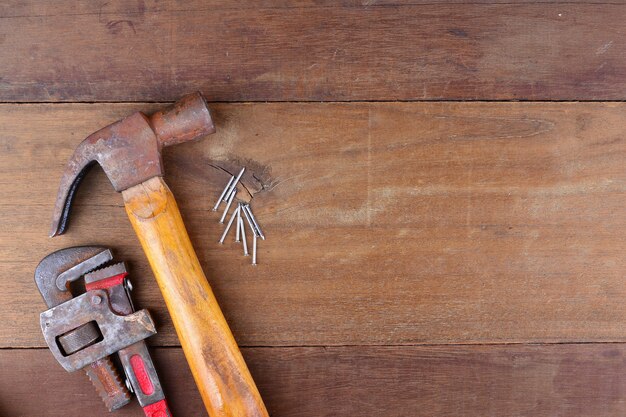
[[50, 92, 215, 237]]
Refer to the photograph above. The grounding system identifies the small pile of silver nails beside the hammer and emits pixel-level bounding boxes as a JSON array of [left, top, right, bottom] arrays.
[[213, 167, 265, 265]]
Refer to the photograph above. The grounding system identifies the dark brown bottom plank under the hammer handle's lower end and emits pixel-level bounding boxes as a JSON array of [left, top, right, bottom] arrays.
[[0, 344, 626, 417]]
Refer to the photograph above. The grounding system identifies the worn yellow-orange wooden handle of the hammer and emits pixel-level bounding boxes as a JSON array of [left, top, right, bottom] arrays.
[[122, 177, 268, 417]]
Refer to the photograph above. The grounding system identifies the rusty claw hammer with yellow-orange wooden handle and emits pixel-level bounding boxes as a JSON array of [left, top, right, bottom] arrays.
[[50, 93, 268, 417]]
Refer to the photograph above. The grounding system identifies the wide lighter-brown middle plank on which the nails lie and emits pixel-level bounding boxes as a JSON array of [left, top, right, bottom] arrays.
[[0, 103, 626, 347]]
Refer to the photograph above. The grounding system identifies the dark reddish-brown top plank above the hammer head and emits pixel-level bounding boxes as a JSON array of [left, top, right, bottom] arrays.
[[0, 0, 626, 102]]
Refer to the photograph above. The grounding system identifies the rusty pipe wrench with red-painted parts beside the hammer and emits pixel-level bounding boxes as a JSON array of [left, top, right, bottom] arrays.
[[35, 246, 169, 415]]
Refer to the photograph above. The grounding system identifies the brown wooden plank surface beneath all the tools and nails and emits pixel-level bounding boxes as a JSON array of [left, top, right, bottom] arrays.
[[0, 0, 626, 417]]
